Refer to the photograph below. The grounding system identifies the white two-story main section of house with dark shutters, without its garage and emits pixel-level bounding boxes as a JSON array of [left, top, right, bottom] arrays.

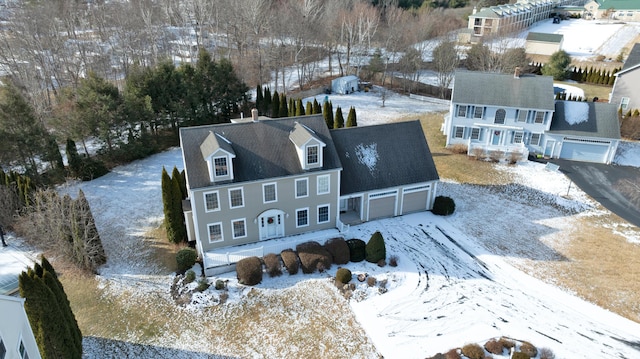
[[442, 70, 554, 159]]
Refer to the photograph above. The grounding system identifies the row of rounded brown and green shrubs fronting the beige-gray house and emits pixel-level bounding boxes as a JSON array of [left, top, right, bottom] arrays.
[[236, 232, 387, 285]]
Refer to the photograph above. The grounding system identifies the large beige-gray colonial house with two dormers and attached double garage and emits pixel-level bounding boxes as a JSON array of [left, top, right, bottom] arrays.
[[180, 115, 438, 269]]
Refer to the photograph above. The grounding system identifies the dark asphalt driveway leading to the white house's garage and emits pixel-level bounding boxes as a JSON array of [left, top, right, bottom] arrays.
[[553, 160, 640, 227]]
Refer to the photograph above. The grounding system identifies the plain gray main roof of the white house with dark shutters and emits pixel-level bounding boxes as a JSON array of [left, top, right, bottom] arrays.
[[451, 71, 554, 111]]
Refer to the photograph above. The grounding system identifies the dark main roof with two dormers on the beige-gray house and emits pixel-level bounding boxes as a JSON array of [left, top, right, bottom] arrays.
[[180, 115, 341, 189]]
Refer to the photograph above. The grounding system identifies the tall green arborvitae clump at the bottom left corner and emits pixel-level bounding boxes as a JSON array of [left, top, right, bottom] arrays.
[[18, 257, 82, 359]]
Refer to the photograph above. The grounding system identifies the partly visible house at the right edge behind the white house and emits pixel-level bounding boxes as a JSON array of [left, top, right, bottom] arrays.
[[609, 43, 640, 114]]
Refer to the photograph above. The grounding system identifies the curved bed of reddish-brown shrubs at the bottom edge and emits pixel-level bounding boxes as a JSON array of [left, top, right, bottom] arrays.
[[427, 337, 555, 359]]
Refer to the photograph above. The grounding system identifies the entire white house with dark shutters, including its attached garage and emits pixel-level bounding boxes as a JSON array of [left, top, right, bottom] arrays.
[[442, 70, 620, 163]]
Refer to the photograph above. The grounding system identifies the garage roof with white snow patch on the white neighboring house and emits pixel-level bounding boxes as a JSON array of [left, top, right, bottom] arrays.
[[549, 101, 620, 139]]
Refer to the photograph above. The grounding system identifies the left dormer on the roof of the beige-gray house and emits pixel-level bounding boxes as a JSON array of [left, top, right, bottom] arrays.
[[200, 131, 236, 183]]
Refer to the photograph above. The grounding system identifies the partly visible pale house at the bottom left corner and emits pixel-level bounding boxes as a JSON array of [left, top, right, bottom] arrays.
[[0, 295, 41, 359]]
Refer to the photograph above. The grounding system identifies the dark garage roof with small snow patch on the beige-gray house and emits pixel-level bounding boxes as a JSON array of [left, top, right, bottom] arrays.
[[331, 121, 439, 195]]
